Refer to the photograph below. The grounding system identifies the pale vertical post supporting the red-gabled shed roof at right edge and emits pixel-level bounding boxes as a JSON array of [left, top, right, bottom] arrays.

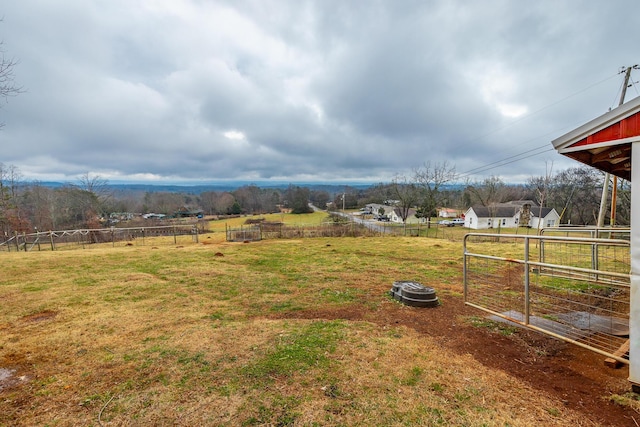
[[629, 142, 640, 392]]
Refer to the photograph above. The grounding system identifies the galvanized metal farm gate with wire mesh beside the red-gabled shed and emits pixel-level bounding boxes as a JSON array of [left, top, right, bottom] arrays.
[[464, 233, 631, 363]]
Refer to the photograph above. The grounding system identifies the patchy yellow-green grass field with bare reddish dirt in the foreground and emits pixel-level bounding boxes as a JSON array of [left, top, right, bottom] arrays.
[[0, 216, 640, 426]]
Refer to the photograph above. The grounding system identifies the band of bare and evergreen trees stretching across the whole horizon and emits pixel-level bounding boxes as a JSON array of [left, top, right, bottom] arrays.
[[0, 163, 631, 237]]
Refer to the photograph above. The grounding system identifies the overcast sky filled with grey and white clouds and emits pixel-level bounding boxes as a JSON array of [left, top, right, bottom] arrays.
[[0, 0, 640, 183]]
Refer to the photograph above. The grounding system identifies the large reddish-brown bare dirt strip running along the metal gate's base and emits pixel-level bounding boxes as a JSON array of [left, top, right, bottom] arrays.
[[272, 297, 640, 426]]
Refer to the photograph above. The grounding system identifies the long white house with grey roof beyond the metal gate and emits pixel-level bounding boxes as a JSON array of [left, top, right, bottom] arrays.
[[464, 200, 560, 230]]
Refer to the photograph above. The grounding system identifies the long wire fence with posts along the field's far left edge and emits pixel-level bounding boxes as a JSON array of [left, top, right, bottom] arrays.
[[0, 222, 206, 252]]
